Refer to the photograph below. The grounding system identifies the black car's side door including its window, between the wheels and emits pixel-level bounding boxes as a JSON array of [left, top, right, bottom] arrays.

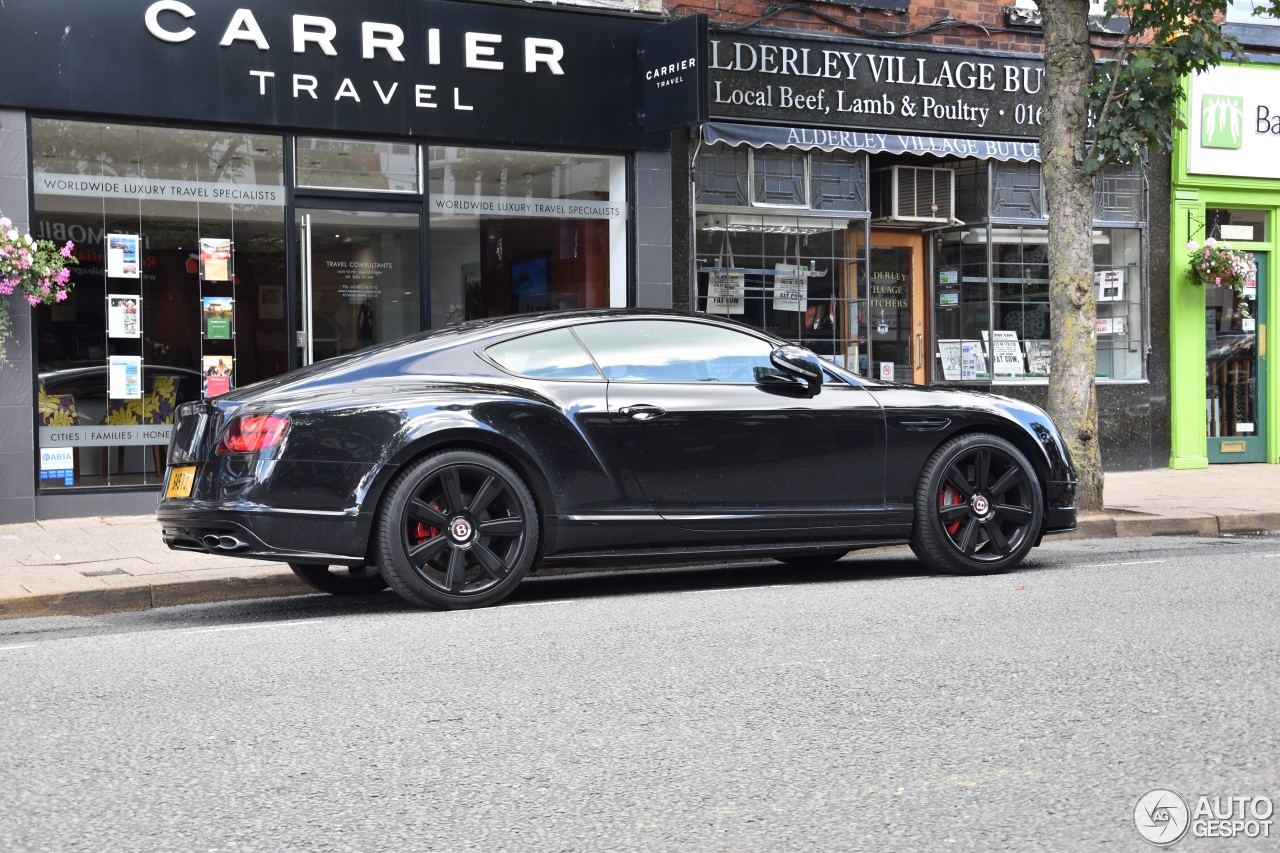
[[577, 318, 886, 530]]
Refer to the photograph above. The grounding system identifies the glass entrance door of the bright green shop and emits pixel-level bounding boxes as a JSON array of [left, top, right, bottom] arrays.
[[1204, 252, 1268, 462]]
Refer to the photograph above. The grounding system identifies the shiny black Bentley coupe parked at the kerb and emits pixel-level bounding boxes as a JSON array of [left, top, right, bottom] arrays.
[[157, 310, 1075, 608]]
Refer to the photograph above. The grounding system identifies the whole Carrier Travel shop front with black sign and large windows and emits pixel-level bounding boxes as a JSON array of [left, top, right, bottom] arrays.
[[0, 0, 671, 520]]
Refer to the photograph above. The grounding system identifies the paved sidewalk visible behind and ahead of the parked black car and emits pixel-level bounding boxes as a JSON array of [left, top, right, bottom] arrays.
[[0, 465, 1280, 619]]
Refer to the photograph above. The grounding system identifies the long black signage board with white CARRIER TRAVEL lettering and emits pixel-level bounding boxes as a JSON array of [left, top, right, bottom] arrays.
[[0, 0, 669, 149]]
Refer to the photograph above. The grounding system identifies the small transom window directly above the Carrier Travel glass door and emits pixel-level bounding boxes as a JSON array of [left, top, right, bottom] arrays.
[[294, 136, 422, 193]]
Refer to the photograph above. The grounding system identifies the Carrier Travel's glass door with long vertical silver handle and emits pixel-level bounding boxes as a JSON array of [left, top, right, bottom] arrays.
[[297, 207, 422, 364]]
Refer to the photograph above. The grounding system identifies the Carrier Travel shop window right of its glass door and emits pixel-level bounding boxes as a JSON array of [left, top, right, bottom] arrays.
[[428, 146, 627, 327]]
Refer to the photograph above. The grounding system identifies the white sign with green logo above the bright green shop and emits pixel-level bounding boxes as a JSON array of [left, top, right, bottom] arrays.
[[1185, 65, 1280, 178]]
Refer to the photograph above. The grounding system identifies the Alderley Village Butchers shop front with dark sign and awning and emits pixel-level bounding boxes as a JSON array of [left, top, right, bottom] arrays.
[[690, 32, 1167, 467]]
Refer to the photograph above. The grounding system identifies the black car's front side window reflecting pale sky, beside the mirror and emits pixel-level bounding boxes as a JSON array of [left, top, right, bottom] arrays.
[[577, 320, 773, 382]]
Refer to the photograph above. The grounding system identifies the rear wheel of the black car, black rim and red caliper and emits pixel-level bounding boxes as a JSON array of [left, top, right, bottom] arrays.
[[375, 451, 539, 610]]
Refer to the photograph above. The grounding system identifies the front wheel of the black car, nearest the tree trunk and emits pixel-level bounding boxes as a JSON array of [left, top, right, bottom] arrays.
[[911, 433, 1044, 575]]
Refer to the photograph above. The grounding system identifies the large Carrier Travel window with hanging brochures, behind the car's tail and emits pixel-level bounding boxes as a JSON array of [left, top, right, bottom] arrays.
[[32, 119, 288, 489]]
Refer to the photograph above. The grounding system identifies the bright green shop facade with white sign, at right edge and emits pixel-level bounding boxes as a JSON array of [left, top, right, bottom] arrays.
[[1169, 63, 1280, 469]]
